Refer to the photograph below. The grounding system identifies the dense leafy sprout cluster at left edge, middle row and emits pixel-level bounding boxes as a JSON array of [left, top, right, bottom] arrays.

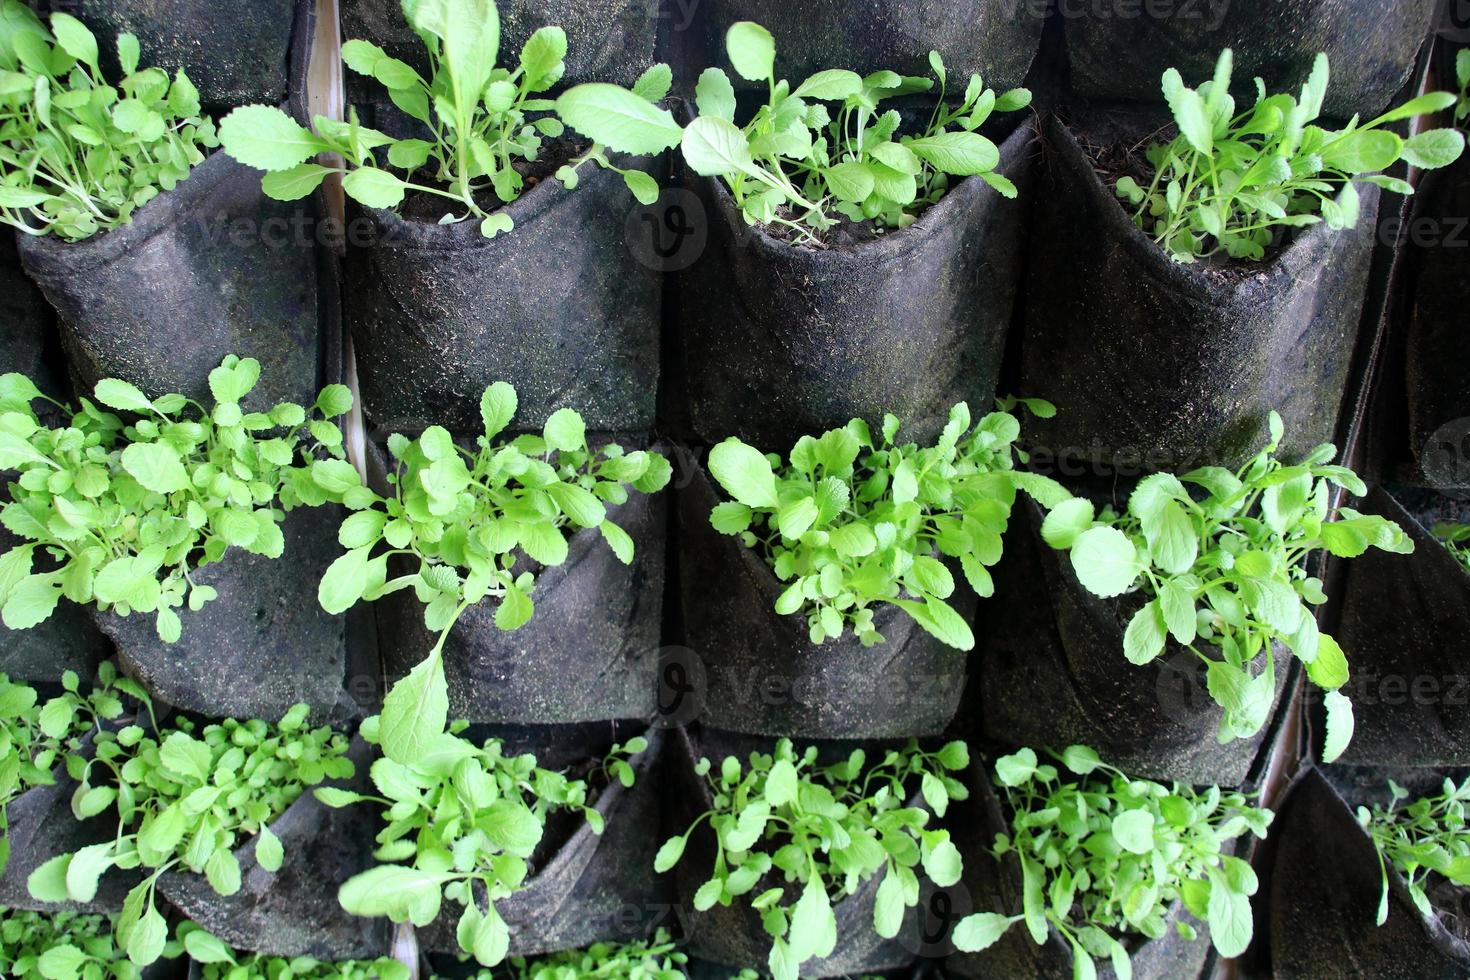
[[0, 356, 351, 644]]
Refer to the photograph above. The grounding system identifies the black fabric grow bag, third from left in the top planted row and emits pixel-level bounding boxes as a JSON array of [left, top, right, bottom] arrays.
[[670, 123, 1036, 453]]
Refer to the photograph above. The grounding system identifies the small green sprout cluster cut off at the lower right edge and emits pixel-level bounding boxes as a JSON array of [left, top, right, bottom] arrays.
[[1357, 779, 1470, 926]]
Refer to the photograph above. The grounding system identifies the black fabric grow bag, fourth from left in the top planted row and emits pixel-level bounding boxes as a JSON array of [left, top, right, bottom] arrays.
[[1017, 110, 1379, 470]]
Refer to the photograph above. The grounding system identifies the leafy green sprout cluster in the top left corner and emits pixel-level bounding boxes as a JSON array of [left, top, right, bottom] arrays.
[[0, 0, 219, 241]]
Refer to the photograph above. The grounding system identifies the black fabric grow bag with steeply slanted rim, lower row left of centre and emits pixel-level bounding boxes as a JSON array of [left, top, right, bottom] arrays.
[[417, 729, 669, 956]]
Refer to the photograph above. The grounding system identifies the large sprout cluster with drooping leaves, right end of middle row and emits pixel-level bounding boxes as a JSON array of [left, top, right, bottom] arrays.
[[1041, 411, 1414, 763]]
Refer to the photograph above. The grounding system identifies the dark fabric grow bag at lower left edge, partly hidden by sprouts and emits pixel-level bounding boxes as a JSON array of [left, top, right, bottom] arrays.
[[0, 738, 143, 914]]
